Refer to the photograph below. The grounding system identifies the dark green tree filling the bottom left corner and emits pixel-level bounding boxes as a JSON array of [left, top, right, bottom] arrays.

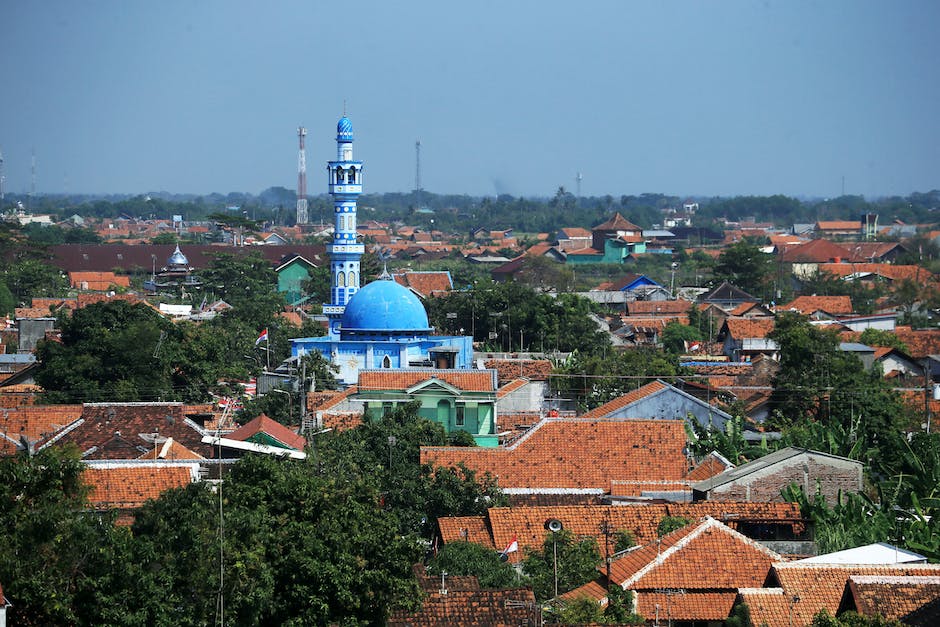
[[0, 448, 132, 625]]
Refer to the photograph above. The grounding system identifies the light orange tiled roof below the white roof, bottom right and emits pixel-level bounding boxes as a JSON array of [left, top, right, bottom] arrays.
[[741, 562, 940, 627]]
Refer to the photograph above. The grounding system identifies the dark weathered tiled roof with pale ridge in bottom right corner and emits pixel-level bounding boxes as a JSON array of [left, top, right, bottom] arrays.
[[848, 575, 940, 625]]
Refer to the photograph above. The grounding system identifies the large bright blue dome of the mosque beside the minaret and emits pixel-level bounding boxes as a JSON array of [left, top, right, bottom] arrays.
[[340, 280, 431, 334]]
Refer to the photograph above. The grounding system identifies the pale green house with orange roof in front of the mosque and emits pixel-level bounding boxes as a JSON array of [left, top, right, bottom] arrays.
[[354, 368, 499, 446]]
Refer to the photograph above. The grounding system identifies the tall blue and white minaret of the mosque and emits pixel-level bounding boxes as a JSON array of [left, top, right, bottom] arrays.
[[323, 115, 365, 337]]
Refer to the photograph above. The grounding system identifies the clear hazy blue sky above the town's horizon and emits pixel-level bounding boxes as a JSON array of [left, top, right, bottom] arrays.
[[0, 0, 940, 197]]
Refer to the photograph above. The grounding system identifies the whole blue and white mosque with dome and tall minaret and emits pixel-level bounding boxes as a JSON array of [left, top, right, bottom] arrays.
[[291, 116, 473, 386]]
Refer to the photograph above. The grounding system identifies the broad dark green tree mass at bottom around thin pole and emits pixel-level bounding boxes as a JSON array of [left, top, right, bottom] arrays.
[[128, 455, 421, 625]]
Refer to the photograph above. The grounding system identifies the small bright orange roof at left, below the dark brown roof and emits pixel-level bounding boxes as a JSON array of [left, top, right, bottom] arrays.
[[82, 464, 195, 509]]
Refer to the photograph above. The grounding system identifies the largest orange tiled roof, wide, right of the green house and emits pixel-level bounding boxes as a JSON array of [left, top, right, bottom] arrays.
[[421, 418, 688, 492]]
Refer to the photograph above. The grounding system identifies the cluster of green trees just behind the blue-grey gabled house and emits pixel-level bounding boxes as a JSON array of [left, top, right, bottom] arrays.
[[552, 347, 680, 410]]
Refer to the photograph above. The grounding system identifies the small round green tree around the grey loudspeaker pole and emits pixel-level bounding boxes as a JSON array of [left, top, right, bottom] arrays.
[[522, 529, 601, 600]]
